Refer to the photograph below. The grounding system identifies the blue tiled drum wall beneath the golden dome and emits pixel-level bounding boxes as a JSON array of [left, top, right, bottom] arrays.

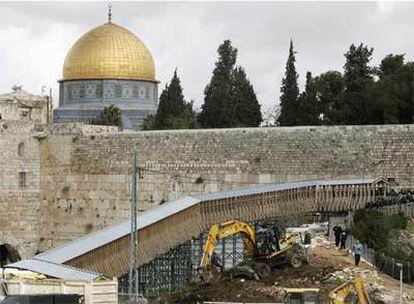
[[53, 79, 158, 129]]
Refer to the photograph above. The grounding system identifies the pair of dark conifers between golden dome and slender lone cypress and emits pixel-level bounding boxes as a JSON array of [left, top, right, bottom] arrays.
[[141, 40, 262, 130]]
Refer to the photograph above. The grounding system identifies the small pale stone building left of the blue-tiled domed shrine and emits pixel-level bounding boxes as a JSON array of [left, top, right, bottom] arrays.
[[0, 86, 50, 124]]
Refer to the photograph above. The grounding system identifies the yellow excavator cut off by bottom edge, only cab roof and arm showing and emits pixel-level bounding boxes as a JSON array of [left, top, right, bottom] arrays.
[[283, 275, 371, 304]]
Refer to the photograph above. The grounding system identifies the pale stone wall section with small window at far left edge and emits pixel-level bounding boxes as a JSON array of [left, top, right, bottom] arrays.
[[0, 121, 41, 257]]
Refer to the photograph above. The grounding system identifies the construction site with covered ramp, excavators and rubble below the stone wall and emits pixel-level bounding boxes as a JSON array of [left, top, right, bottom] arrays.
[[2, 172, 414, 304]]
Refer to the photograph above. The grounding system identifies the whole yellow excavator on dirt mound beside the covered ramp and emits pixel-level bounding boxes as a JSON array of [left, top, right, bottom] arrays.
[[199, 220, 308, 281]]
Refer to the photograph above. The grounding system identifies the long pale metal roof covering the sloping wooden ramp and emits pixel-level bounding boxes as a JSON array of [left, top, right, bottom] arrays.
[[35, 178, 377, 263]]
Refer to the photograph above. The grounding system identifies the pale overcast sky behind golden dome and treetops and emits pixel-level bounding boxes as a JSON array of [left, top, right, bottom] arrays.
[[0, 2, 414, 111]]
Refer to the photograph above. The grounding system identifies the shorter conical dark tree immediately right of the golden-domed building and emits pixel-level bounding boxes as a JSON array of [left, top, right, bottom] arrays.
[[141, 70, 197, 130]]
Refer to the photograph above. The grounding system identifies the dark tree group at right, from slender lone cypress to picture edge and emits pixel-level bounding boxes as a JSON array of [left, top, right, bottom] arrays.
[[277, 41, 414, 126]]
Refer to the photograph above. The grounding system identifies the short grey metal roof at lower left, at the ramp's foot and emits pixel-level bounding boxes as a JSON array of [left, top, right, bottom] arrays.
[[5, 258, 102, 281]]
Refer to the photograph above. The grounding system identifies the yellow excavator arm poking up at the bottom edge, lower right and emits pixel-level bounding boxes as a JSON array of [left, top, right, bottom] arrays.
[[329, 275, 371, 304]]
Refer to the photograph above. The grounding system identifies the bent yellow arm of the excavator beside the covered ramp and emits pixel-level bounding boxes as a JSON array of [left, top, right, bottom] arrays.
[[200, 220, 257, 268]]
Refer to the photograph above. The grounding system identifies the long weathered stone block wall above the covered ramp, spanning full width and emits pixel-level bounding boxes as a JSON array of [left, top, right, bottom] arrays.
[[0, 124, 414, 256]]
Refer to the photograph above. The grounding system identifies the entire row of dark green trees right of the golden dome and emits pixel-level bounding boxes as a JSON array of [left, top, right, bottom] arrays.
[[102, 40, 414, 130]]
